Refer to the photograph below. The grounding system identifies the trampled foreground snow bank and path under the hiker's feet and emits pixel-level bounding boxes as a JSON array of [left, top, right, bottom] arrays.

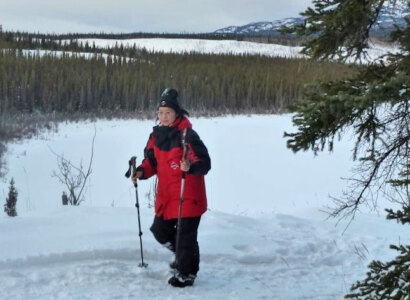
[[0, 207, 403, 299]]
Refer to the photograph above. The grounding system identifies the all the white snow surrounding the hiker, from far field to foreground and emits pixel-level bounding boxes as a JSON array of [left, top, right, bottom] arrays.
[[0, 115, 410, 299]]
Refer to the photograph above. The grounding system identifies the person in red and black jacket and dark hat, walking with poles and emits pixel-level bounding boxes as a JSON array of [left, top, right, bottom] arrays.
[[132, 88, 211, 287]]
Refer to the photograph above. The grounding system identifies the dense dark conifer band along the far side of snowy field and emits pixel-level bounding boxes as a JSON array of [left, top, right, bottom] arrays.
[[0, 49, 353, 115]]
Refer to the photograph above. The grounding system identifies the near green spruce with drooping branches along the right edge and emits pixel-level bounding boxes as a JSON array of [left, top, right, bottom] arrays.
[[284, 0, 410, 299]]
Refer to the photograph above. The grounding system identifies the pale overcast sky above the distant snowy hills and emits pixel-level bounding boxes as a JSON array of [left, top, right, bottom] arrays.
[[0, 0, 311, 33]]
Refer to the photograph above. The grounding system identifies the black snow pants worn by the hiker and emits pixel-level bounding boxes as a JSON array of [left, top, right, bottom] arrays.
[[150, 216, 201, 275]]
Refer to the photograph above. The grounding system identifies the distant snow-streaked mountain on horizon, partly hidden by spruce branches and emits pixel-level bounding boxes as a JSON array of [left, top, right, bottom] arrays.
[[213, 1, 410, 36]]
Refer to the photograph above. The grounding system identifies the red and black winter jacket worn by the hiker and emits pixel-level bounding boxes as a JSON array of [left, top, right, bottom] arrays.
[[137, 117, 211, 220]]
